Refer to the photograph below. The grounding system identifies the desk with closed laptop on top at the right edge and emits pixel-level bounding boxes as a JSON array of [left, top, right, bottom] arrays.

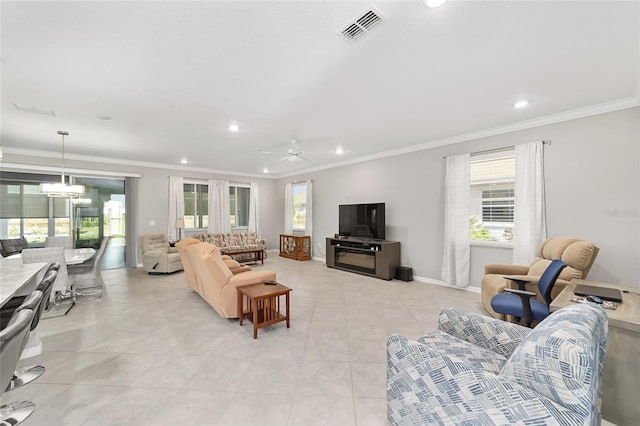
[[550, 279, 640, 426]]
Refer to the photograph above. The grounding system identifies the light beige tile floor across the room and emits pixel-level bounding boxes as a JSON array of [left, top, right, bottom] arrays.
[[2, 253, 482, 426]]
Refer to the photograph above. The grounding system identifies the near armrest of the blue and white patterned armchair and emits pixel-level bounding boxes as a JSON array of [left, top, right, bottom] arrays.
[[387, 335, 592, 425]]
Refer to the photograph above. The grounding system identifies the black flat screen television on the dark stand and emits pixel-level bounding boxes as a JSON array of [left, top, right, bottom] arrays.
[[338, 203, 385, 240]]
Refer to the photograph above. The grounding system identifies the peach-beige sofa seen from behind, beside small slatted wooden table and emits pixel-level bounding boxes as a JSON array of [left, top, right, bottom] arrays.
[[176, 239, 276, 318]]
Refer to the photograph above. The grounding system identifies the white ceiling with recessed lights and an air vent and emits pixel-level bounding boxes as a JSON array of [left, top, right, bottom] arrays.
[[1, 1, 640, 176]]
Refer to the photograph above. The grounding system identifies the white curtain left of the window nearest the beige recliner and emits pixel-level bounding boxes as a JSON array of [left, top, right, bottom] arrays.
[[442, 154, 471, 288]]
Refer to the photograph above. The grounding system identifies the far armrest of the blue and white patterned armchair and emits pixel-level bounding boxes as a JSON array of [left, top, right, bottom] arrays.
[[438, 308, 531, 358]]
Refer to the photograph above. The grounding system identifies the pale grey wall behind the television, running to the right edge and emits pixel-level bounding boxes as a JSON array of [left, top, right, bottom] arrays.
[[276, 108, 640, 286]]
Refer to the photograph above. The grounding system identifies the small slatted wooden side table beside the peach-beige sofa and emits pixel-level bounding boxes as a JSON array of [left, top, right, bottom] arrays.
[[238, 283, 291, 339]]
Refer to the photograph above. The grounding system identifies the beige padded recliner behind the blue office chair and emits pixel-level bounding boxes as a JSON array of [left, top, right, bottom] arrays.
[[480, 237, 600, 320]]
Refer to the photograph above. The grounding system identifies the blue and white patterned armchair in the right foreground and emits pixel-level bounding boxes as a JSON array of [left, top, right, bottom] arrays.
[[387, 304, 607, 425]]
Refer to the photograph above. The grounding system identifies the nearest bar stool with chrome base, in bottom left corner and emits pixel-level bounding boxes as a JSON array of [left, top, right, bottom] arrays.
[[0, 308, 35, 425]]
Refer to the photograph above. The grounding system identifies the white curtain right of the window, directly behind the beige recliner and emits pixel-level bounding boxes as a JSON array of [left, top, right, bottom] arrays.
[[513, 141, 547, 265]]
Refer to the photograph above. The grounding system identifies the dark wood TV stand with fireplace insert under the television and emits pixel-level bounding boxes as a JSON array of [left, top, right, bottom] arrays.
[[326, 237, 400, 280]]
